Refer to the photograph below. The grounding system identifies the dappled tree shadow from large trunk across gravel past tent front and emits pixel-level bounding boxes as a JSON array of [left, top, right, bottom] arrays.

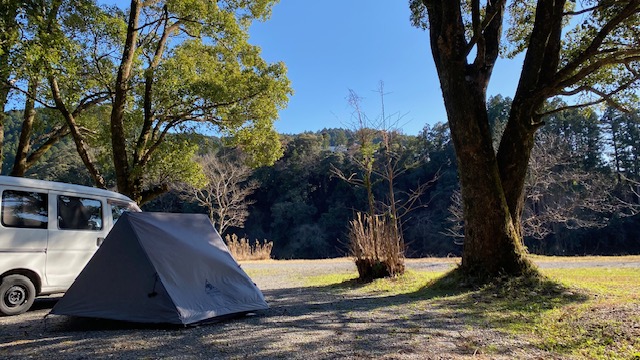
[[0, 273, 587, 359]]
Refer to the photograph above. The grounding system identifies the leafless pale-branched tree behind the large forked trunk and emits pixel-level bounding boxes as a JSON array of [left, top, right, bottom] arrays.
[[446, 133, 640, 245]]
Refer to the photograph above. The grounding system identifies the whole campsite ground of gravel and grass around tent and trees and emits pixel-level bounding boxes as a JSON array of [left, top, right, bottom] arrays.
[[0, 256, 640, 360]]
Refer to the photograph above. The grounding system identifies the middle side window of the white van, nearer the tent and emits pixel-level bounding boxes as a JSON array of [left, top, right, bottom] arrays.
[[58, 195, 102, 230]]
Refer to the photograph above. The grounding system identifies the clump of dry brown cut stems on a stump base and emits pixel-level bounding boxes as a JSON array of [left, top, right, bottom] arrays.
[[349, 212, 405, 281]]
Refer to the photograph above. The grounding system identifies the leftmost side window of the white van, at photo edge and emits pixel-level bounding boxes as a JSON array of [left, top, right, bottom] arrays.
[[2, 190, 49, 229]]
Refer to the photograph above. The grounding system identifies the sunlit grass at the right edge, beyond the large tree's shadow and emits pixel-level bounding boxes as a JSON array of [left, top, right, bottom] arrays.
[[534, 268, 640, 359]]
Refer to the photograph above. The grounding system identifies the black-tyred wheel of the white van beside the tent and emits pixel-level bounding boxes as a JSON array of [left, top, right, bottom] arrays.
[[0, 275, 36, 315]]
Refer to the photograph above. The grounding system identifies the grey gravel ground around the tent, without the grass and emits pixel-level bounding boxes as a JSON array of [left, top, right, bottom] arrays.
[[0, 257, 640, 360]]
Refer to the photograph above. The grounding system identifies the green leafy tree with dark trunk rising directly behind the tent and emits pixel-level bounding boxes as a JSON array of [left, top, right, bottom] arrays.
[[109, 0, 291, 203]]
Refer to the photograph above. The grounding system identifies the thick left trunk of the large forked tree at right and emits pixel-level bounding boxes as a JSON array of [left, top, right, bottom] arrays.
[[424, 0, 529, 277]]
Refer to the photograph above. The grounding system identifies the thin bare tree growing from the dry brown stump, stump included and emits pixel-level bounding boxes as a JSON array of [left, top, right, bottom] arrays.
[[332, 82, 435, 280]]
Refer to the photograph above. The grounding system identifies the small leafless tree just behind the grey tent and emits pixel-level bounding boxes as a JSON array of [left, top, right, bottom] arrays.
[[176, 154, 259, 234]]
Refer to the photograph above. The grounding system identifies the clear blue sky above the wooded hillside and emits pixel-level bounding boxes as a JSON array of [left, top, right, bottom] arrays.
[[99, 0, 521, 135]]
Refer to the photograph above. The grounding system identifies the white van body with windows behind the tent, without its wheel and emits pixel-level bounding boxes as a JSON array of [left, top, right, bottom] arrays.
[[0, 176, 140, 295]]
